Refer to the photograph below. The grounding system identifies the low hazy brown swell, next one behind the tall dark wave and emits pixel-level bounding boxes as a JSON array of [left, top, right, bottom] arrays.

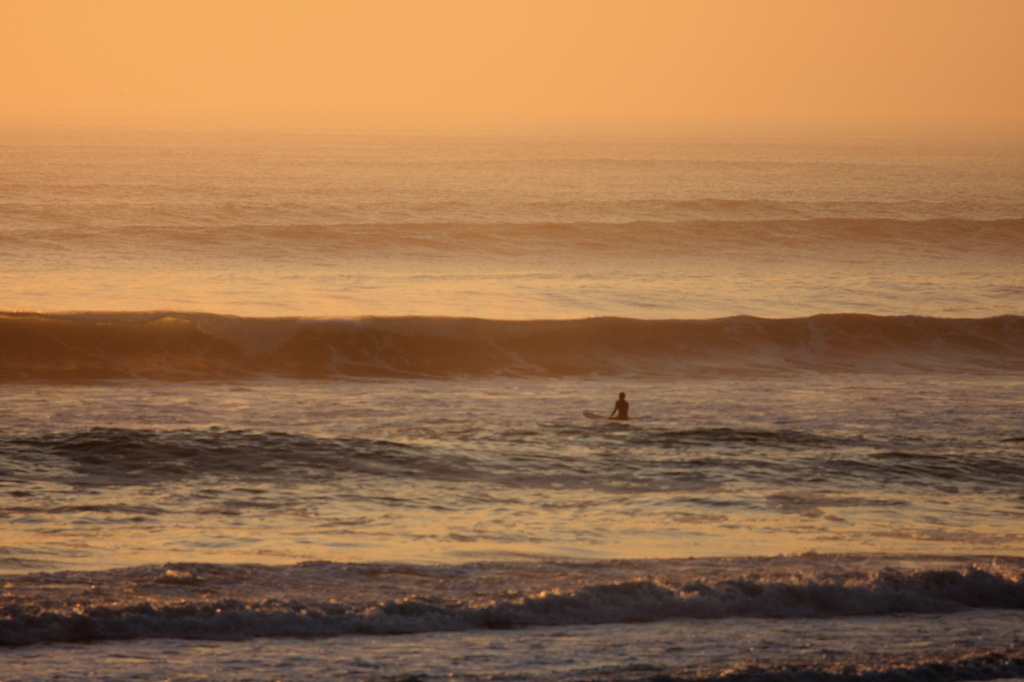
[[9, 218, 1024, 249]]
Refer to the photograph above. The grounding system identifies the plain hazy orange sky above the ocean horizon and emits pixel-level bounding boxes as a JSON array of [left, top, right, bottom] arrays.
[[0, 0, 1024, 129]]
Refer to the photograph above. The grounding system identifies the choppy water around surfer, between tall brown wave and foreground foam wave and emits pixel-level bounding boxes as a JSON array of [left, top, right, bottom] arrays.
[[0, 376, 1024, 568]]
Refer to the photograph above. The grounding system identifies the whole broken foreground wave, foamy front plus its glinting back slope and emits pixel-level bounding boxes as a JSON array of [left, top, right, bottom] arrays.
[[0, 562, 1024, 646]]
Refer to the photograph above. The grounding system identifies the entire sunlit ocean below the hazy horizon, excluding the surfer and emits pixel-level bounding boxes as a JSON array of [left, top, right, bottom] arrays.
[[0, 129, 1024, 682]]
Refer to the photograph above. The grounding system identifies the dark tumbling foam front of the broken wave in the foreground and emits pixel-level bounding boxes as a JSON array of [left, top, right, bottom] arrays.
[[0, 569, 1024, 645]]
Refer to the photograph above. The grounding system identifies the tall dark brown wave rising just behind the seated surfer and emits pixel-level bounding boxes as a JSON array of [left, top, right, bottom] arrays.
[[0, 312, 1024, 381]]
